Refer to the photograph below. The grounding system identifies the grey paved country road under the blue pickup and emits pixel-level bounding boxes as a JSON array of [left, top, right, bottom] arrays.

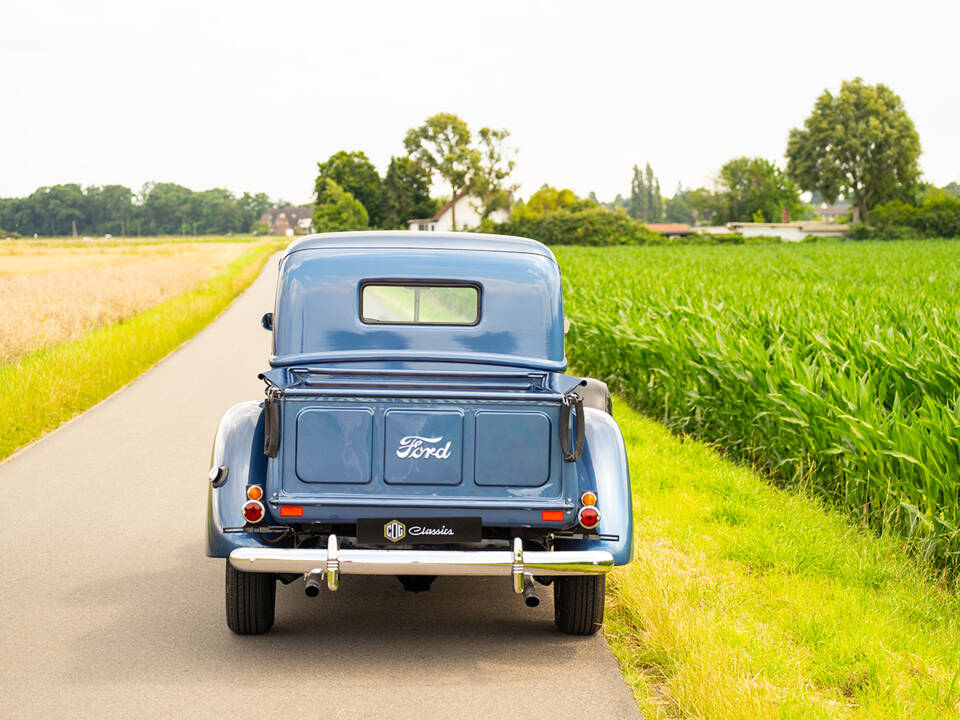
[[0, 262, 637, 720]]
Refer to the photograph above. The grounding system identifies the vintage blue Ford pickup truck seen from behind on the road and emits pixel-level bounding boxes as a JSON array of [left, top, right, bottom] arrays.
[[207, 232, 633, 635]]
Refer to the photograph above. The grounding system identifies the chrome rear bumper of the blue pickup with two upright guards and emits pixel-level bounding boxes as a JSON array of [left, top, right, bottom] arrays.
[[230, 535, 613, 593]]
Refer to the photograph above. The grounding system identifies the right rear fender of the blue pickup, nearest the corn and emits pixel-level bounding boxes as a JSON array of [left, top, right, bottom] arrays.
[[557, 407, 633, 565]]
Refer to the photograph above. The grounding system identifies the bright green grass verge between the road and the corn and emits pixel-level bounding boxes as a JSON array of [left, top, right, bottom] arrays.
[[605, 399, 960, 720]]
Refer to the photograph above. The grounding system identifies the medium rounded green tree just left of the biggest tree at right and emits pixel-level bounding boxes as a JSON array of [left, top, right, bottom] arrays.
[[714, 157, 802, 223]]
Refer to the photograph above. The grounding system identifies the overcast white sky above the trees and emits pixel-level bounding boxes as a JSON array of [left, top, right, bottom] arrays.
[[0, 0, 960, 202]]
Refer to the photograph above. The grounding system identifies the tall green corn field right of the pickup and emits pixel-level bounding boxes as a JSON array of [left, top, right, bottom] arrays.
[[555, 241, 960, 570]]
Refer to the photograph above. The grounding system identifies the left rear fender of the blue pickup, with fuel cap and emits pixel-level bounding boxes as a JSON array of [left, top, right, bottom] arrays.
[[207, 400, 267, 557]]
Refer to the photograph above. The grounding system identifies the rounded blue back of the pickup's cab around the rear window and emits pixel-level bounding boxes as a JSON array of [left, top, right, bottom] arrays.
[[270, 231, 566, 371]]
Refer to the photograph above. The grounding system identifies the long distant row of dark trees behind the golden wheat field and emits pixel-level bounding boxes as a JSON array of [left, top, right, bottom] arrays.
[[0, 183, 273, 236]]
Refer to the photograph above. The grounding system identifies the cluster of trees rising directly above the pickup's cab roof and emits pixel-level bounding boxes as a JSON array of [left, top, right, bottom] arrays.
[[313, 113, 516, 232]]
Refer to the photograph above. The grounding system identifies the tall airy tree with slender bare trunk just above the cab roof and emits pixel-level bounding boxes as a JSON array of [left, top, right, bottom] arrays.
[[403, 113, 479, 230]]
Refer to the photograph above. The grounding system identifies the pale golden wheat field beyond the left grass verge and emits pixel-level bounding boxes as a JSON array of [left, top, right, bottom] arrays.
[[0, 241, 248, 363]]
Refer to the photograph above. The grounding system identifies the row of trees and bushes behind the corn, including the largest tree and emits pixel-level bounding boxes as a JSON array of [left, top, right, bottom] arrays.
[[605, 78, 960, 226]]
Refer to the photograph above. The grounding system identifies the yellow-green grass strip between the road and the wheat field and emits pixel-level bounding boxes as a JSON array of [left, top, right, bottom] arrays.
[[0, 241, 286, 460]]
